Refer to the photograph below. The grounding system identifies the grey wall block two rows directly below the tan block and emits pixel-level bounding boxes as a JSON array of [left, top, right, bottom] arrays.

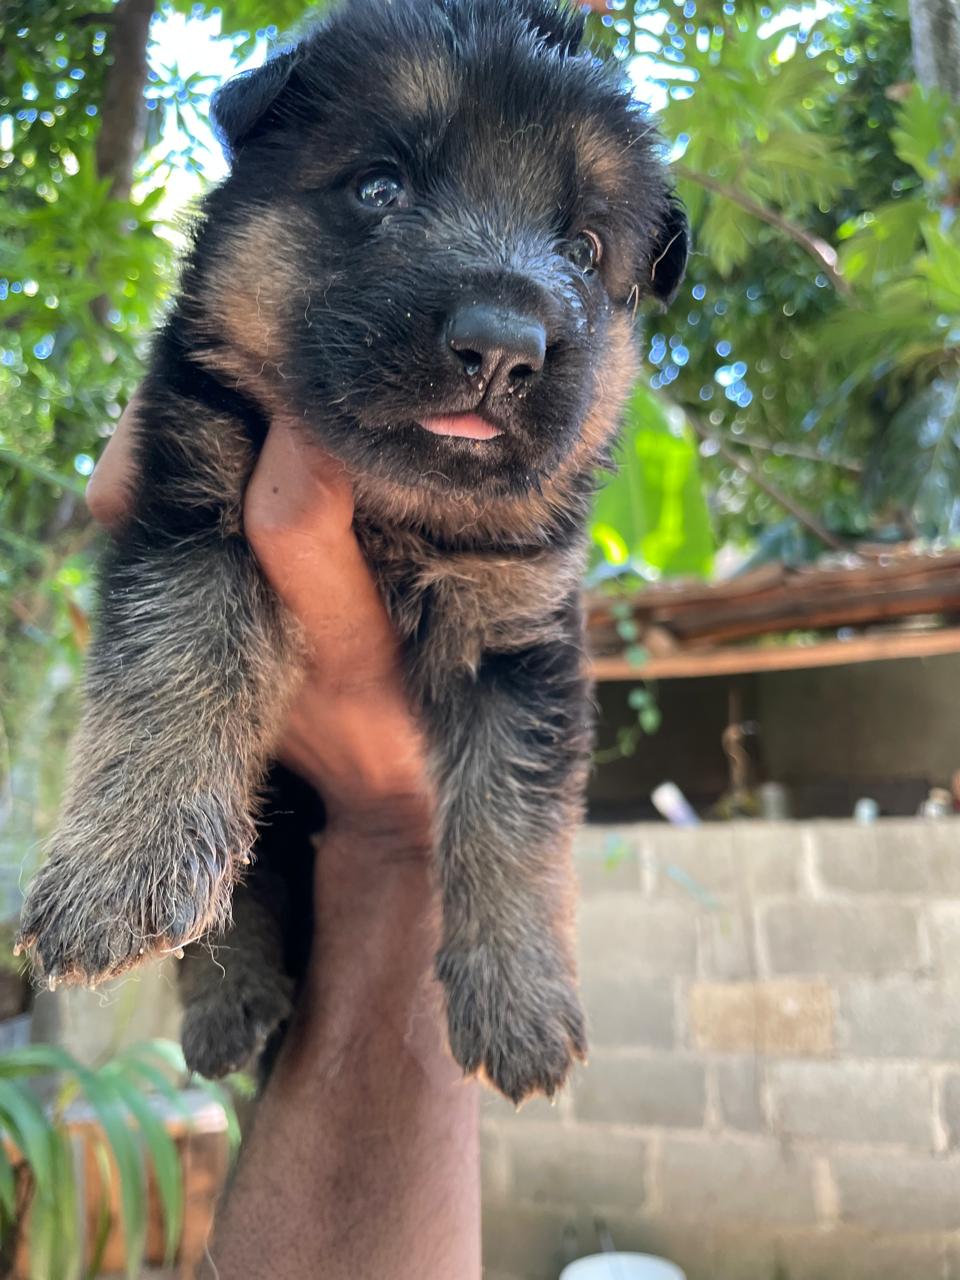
[[658, 1135, 817, 1230]]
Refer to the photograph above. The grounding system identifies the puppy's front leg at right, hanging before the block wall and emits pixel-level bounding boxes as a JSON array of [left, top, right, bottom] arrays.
[[436, 624, 589, 1102]]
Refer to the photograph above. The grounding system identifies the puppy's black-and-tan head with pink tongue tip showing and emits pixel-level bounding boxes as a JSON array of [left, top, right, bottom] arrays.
[[199, 0, 686, 509]]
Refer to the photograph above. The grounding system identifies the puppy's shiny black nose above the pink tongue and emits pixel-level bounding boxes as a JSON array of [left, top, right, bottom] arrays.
[[445, 306, 547, 396]]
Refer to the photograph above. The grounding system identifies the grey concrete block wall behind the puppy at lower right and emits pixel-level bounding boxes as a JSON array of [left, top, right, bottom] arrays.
[[483, 820, 960, 1280]]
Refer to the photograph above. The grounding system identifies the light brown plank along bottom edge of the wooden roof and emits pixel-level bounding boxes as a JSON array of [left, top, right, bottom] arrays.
[[590, 627, 960, 681]]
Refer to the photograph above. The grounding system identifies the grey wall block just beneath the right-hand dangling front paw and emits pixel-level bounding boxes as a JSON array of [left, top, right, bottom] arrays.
[[503, 1125, 646, 1212]]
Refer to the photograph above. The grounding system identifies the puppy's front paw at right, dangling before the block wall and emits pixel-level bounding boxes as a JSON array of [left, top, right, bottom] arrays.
[[436, 943, 586, 1105]]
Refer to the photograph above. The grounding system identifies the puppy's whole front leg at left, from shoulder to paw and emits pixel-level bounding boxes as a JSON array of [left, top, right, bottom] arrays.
[[20, 379, 294, 982]]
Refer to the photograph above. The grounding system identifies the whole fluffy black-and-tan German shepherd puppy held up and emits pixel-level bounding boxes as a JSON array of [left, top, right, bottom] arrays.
[[20, 0, 687, 1101]]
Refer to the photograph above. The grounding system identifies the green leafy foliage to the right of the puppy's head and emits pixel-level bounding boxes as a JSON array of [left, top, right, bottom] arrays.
[[583, 0, 960, 560]]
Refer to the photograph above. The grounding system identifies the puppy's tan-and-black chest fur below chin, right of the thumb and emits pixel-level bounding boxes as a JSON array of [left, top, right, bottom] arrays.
[[358, 529, 581, 686]]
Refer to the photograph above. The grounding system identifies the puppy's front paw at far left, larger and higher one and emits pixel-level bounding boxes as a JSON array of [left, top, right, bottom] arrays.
[[17, 799, 247, 987]]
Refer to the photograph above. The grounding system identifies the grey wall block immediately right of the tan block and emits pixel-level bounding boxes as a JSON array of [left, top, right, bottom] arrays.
[[837, 974, 960, 1060]]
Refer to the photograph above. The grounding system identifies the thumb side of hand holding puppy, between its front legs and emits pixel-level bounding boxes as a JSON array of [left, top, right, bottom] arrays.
[[244, 420, 426, 809]]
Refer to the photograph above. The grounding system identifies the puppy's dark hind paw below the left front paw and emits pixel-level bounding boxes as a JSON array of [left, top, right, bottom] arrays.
[[180, 959, 293, 1080]]
